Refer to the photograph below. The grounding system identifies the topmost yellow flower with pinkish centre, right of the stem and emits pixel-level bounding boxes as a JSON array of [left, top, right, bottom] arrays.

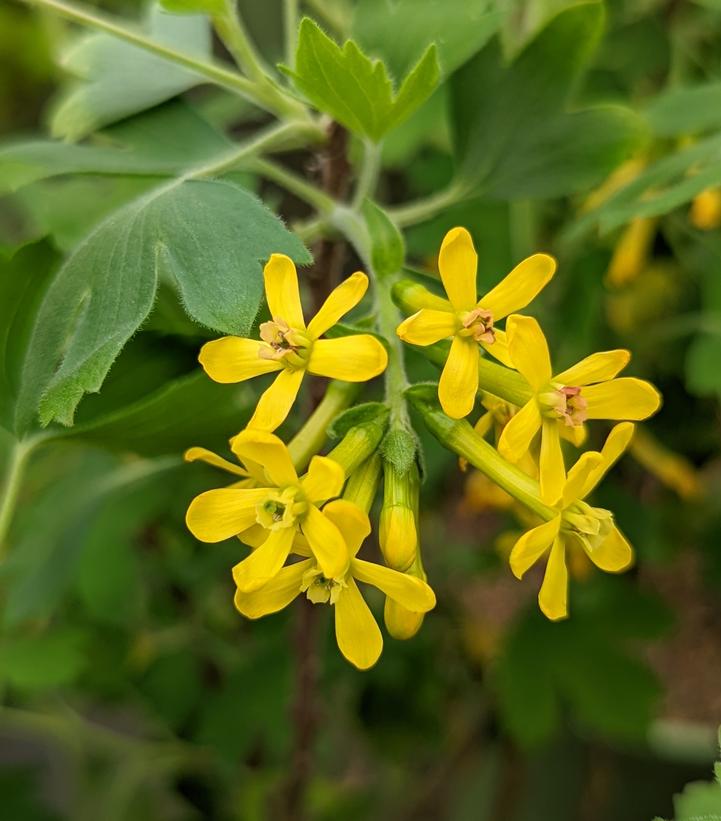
[[397, 228, 556, 419]]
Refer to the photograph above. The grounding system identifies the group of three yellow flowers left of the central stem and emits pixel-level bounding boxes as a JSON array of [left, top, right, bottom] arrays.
[[186, 254, 435, 669]]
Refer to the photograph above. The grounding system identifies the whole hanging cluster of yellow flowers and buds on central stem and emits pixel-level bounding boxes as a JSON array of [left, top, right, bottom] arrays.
[[186, 228, 660, 669]]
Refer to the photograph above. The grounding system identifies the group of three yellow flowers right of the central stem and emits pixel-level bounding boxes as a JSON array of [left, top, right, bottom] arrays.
[[396, 228, 661, 620]]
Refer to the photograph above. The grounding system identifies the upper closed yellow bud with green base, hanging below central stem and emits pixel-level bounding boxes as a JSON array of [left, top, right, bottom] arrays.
[[378, 459, 420, 570]]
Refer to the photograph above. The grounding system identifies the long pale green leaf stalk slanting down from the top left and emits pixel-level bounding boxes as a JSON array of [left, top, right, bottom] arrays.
[[26, 0, 308, 119]]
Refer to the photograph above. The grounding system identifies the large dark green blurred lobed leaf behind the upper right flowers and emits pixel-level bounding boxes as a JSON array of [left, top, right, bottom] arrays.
[[451, 2, 643, 199]]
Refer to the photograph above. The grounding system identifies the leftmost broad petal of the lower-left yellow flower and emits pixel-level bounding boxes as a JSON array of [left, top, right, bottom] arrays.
[[185, 488, 268, 542]]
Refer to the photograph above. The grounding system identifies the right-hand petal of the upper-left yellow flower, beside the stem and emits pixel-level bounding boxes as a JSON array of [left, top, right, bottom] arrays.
[[308, 334, 388, 382]]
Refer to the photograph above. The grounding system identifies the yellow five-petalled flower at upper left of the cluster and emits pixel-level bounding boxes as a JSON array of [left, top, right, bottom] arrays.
[[198, 254, 388, 431]]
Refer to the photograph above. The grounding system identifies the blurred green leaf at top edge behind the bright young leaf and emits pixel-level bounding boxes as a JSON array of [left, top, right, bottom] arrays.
[[352, 0, 502, 77]]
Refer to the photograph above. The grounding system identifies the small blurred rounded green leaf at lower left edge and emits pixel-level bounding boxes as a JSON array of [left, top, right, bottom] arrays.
[[0, 630, 85, 690]]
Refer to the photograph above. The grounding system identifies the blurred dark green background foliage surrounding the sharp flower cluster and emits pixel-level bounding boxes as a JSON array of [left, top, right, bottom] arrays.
[[0, 0, 721, 821]]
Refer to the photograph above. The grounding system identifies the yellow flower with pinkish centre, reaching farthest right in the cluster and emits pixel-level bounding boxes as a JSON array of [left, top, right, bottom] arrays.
[[498, 314, 661, 504]]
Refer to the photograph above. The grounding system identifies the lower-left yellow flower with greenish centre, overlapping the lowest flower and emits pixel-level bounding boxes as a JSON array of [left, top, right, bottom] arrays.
[[185, 429, 350, 592]]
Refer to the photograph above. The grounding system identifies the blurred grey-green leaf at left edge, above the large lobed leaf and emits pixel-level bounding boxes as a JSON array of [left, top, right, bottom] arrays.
[[0, 102, 231, 194]]
